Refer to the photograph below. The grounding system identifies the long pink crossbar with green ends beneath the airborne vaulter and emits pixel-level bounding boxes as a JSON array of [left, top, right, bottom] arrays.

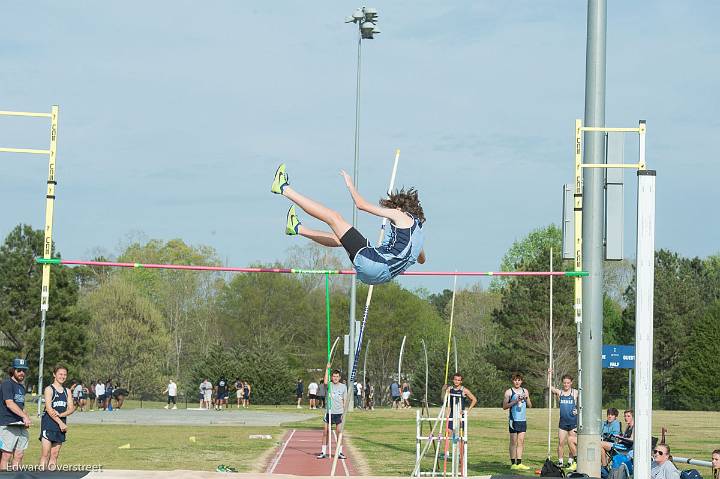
[[35, 258, 589, 277]]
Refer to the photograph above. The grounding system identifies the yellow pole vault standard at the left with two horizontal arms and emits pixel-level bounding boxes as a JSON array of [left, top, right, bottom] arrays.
[[0, 105, 59, 416]]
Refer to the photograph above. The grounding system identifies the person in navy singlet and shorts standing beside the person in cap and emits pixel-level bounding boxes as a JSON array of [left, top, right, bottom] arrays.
[[40, 365, 75, 471]]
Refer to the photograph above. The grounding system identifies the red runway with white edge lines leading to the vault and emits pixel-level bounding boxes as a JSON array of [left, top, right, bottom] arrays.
[[265, 429, 358, 476]]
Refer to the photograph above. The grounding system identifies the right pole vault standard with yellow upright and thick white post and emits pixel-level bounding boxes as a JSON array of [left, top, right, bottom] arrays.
[[574, 119, 655, 477]]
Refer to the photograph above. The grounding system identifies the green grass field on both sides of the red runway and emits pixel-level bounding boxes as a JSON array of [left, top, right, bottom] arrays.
[[14, 404, 720, 476]]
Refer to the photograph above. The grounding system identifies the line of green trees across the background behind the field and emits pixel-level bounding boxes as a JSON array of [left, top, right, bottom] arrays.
[[0, 225, 720, 410]]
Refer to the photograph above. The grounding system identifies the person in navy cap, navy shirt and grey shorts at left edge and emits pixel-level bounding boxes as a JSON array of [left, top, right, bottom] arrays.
[[0, 358, 31, 471]]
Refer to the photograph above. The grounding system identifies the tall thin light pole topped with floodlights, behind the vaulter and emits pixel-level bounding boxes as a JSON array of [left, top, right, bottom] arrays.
[[345, 7, 380, 411]]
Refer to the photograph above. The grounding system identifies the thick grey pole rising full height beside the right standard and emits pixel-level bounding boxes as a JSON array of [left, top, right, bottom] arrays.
[[577, 0, 607, 477]]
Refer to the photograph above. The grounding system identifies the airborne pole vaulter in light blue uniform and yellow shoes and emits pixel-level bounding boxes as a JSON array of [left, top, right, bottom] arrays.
[[270, 164, 425, 285]]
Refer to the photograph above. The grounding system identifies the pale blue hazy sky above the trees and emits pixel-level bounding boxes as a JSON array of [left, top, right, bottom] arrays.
[[0, 0, 720, 290]]
